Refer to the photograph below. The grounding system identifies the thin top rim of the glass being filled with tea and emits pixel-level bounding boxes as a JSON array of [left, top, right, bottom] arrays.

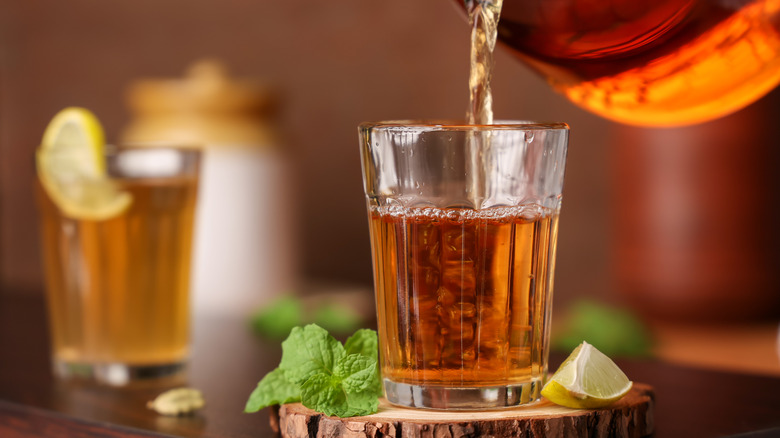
[[358, 119, 569, 131]]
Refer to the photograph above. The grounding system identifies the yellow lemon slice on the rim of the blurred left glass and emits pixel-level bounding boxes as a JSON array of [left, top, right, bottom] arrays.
[[35, 107, 133, 220]]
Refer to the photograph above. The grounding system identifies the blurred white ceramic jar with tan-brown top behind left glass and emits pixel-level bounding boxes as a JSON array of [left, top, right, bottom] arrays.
[[122, 61, 297, 316]]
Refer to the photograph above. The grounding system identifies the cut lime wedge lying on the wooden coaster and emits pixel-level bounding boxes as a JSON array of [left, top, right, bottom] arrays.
[[542, 342, 632, 409]]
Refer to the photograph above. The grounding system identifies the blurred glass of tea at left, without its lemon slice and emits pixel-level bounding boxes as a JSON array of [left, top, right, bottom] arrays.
[[39, 145, 200, 385]]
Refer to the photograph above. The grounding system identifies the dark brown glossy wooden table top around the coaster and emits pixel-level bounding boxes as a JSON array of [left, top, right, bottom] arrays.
[[0, 290, 780, 438]]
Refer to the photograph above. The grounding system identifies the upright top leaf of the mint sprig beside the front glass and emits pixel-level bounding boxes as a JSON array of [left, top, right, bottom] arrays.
[[279, 324, 344, 385]]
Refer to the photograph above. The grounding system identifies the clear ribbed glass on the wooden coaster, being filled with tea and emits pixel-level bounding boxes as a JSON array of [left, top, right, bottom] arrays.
[[359, 121, 568, 409]]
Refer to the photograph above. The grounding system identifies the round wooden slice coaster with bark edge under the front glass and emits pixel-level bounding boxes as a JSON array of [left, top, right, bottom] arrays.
[[271, 383, 654, 438]]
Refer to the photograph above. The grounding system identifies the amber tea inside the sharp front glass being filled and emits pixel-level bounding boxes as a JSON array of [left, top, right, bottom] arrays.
[[370, 205, 558, 388]]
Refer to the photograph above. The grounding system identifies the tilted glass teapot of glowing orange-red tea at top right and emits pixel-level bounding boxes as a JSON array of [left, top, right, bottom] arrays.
[[458, 0, 780, 126]]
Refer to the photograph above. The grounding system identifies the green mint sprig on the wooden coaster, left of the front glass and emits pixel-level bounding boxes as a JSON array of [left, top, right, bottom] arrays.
[[244, 324, 382, 417]]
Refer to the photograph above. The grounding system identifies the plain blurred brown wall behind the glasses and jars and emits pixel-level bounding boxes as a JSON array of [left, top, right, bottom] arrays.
[[0, 0, 777, 318]]
